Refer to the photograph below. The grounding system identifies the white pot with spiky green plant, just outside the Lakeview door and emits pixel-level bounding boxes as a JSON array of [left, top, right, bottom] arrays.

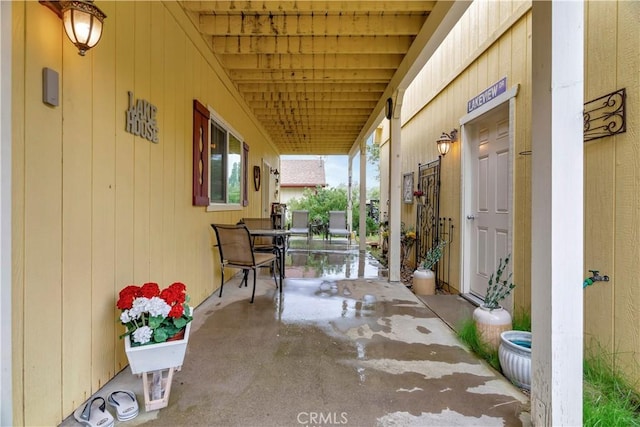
[[473, 255, 516, 350]]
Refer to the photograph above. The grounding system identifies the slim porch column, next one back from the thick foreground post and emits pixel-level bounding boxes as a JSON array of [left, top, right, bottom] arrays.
[[387, 90, 404, 282]]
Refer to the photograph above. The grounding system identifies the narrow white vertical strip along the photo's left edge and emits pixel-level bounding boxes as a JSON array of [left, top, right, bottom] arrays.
[[0, 2, 13, 426]]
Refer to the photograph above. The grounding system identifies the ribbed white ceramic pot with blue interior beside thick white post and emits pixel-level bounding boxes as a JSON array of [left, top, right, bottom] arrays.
[[498, 331, 531, 390]]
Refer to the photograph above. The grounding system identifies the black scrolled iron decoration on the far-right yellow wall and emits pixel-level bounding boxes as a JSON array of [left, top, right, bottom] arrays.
[[583, 88, 627, 142]]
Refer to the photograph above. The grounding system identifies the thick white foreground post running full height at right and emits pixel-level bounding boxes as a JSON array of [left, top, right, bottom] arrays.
[[531, 1, 584, 426]]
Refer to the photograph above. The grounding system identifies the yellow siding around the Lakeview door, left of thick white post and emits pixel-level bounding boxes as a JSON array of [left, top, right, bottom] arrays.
[[388, 2, 531, 309]]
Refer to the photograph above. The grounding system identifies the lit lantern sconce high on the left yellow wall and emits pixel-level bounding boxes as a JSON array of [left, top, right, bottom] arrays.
[[40, 0, 107, 56]]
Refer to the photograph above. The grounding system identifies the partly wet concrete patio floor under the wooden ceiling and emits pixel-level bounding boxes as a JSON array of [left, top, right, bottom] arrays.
[[61, 239, 530, 426]]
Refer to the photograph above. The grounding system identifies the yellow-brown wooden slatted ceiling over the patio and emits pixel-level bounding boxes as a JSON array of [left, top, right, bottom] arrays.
[[181, 0, 437, 155]]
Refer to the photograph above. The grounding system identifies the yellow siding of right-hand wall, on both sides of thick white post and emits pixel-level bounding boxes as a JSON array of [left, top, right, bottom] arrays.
[[381, 1, 640, 384]]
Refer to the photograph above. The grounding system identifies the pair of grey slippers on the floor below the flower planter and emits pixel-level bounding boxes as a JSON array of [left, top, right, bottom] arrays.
[[73, 390, 139, 427]]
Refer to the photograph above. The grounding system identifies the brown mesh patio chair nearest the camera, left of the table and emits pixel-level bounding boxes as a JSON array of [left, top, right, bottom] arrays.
[[211, 224, 282, 303]]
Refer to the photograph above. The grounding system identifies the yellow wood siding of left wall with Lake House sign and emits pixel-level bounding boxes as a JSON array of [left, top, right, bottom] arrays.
[[12, 2, 278, 425]]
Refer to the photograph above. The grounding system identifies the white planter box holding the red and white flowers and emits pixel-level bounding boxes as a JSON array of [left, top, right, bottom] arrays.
[[124, 320, 193, 374]]
